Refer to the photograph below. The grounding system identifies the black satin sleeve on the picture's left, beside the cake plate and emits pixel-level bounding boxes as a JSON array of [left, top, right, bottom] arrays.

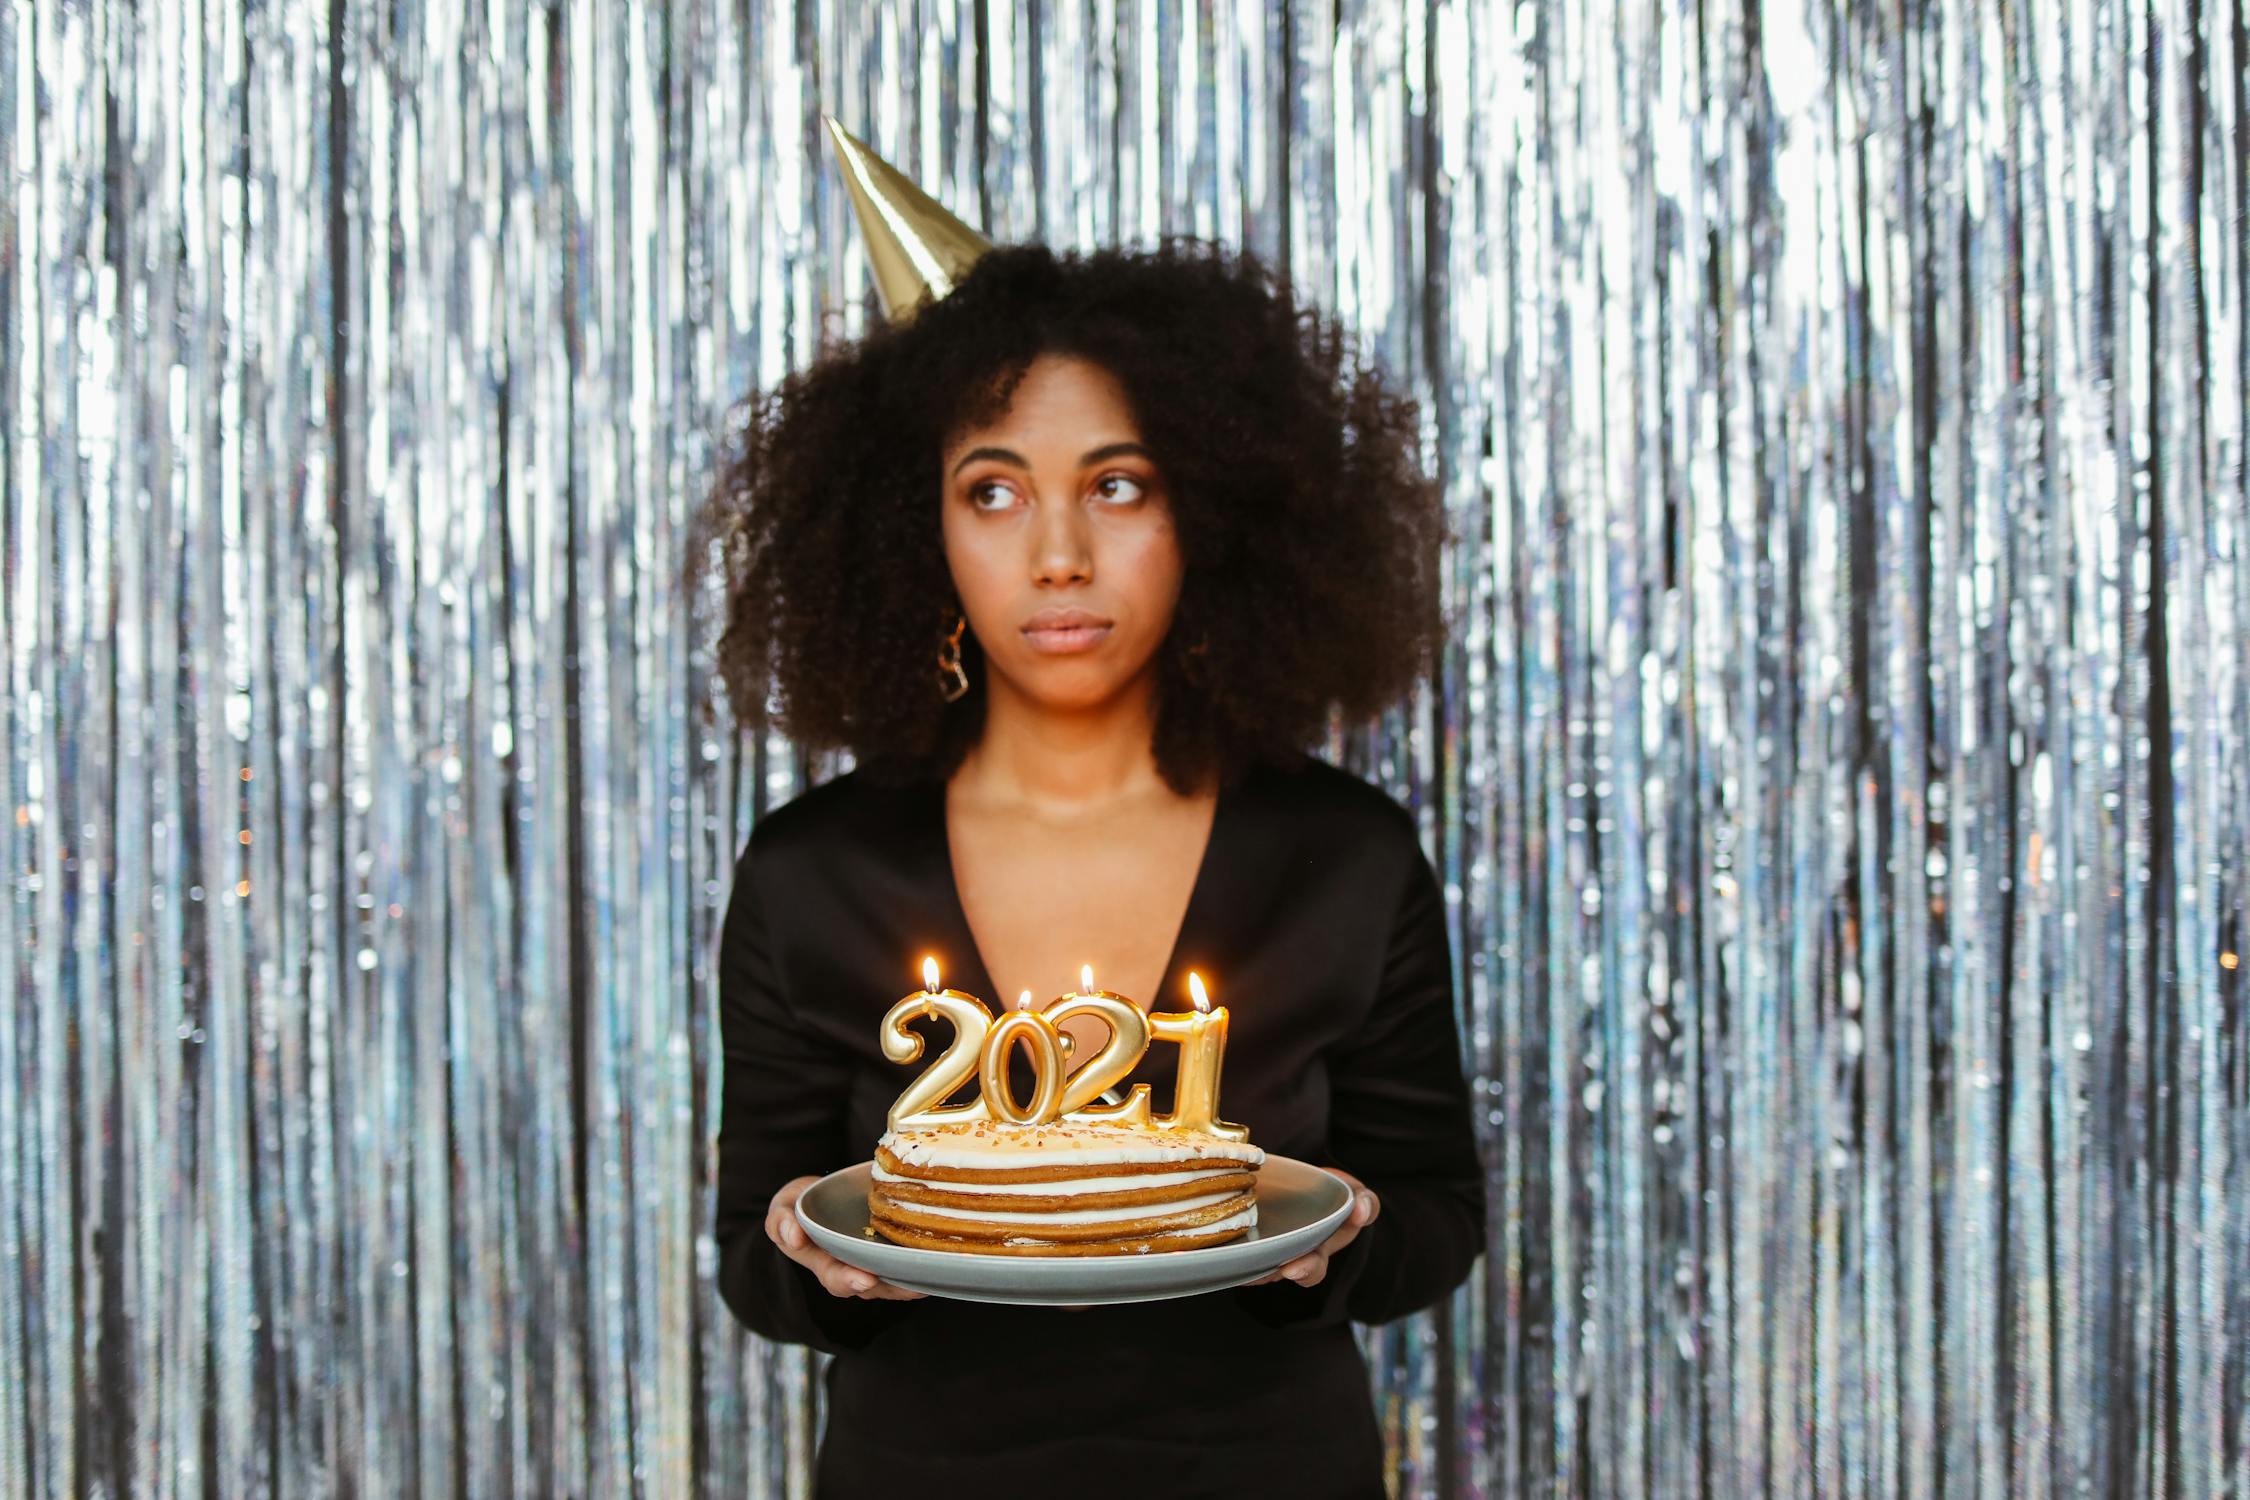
[[713, 834, 914, 1354]]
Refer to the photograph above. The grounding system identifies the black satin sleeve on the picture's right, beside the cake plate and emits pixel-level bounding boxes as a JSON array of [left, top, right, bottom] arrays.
[[1235, 843, 1485, 1327]]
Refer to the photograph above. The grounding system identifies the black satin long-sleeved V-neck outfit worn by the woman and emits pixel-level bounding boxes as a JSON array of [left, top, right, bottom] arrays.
[[716, 758, 1485, 1500]]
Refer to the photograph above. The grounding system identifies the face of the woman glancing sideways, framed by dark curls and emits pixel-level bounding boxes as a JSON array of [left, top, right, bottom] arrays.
[[943, 355, 1181, 708]]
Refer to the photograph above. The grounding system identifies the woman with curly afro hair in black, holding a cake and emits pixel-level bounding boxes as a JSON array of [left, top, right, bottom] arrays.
[[702, 241, 1485, 1500]]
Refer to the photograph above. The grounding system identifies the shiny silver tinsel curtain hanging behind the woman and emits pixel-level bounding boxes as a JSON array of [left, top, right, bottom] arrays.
[[0, 0, 2250, 1498]]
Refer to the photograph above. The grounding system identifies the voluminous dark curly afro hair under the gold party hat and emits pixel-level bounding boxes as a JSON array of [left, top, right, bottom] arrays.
[[686, 236, 1447, 794]]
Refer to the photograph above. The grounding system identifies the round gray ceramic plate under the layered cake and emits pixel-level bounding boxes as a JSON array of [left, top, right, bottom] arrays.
[[797, 1151, 1352, 1307]]
